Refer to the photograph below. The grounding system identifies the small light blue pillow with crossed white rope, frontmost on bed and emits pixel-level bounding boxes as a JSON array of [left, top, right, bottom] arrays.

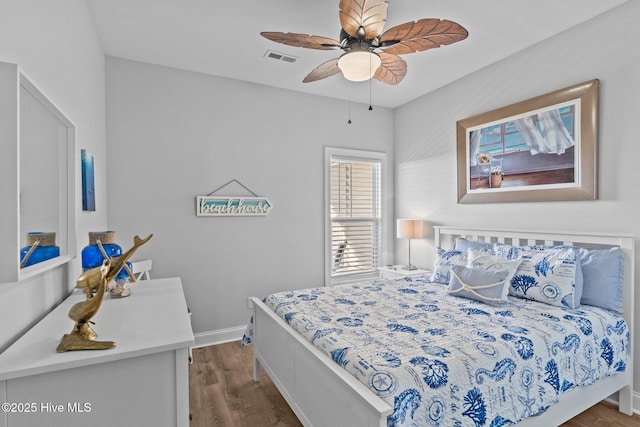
[[448, 265, 509, 303]]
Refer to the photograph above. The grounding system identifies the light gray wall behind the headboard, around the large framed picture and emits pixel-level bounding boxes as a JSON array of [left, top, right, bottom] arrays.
[[394, 1, 640, 402]]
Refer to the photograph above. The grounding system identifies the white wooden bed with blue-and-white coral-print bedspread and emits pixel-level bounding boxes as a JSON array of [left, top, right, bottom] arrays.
[[252, 227, 634, 427]]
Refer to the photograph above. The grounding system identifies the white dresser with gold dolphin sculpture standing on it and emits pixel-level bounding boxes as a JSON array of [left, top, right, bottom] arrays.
[[0, 277, 194, 427]]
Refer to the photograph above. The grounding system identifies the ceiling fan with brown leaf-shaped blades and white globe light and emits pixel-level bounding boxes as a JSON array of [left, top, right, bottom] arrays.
[[260, 0, 469, 85]]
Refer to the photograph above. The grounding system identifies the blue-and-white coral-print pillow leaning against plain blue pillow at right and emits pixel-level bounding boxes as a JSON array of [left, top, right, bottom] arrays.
[[494, 244, 583, 308]]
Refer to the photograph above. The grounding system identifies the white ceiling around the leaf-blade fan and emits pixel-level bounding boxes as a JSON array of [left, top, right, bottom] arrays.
[[87, 0, 627, 108]]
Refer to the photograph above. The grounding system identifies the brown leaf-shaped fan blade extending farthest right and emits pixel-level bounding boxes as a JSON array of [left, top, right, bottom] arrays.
[[380, 18, 469, 55]]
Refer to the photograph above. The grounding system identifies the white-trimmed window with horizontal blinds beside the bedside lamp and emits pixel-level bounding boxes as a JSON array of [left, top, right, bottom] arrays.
[[325, 148, 386, 283]]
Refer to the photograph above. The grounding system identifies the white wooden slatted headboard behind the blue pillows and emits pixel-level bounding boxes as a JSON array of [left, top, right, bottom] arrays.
[[434, 226, 635, 412]]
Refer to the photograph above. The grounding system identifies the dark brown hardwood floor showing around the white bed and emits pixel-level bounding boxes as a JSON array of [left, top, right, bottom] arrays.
[[189, 341, 640, 427]]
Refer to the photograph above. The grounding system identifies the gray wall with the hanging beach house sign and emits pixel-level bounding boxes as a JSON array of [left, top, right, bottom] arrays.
[[107, 57, 393, 334]]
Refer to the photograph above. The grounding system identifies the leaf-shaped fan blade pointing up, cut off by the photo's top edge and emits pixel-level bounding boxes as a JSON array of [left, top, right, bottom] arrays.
[[338, 0, 389, 40]]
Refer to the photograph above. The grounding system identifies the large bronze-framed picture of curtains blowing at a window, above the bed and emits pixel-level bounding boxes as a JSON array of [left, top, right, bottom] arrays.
[[456, 79, 599, 203]]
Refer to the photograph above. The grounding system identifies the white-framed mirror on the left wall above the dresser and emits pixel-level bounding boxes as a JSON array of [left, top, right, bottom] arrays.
[[0, 63, 76, 283]]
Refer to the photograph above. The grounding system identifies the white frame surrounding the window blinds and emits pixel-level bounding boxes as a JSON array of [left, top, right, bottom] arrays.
[[324, 147, 392, 286]]
